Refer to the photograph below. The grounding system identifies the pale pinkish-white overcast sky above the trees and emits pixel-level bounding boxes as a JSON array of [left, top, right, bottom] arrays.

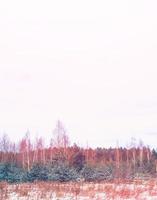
[[0, 0, 157, 147]]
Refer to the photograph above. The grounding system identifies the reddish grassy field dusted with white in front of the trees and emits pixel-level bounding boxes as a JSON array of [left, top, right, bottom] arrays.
[[0, 179, 157, 200]]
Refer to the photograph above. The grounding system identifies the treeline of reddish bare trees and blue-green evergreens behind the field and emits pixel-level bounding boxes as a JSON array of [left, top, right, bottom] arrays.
[[0, 121, 157, 182]]
